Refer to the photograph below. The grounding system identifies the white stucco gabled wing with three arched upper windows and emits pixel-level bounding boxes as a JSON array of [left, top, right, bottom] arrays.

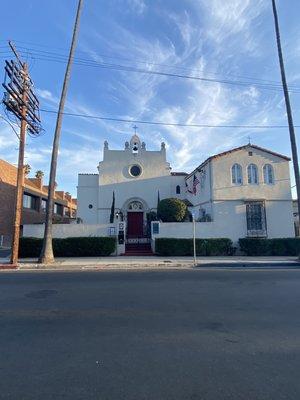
[[186, 144, 295, 238]]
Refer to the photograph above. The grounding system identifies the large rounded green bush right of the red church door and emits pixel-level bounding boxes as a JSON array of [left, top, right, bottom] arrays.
[[157, 198, 187, 222]]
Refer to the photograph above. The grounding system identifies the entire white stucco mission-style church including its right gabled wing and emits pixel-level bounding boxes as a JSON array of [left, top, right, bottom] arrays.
[[78, 135, 294, 244]]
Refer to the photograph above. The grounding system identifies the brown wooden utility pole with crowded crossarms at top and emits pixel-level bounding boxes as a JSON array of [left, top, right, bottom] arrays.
[[2, 42, 41, 265]]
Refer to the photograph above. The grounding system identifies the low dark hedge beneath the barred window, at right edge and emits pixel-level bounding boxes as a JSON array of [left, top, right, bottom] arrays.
[[239, 238, 300, 256]]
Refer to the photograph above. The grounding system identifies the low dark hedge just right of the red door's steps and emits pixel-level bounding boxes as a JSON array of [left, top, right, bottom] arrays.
[[155, 238, 233, 256]]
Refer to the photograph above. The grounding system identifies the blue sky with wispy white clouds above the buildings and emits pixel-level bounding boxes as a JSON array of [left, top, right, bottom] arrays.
[[0, 0, 300, 196]]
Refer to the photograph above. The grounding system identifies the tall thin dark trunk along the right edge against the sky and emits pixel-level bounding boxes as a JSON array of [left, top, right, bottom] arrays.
[[272, 0, 300, 231]]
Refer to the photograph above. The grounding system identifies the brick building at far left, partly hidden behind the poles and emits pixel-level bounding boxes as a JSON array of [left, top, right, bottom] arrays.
[[0, 160, 77, 246]]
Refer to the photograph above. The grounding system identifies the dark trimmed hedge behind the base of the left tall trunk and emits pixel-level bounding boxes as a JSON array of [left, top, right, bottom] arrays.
[[19, 237, 116, 258]]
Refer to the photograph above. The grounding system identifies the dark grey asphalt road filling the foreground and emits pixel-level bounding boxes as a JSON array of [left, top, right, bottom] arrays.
[[0, 270, 300, 400]]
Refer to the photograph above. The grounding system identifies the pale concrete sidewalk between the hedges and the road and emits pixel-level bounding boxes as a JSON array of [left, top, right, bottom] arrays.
[[0, 256, 300, 271]]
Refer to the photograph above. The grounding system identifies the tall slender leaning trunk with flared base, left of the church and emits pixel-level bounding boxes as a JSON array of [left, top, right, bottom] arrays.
[[39, 0, 83, 264]]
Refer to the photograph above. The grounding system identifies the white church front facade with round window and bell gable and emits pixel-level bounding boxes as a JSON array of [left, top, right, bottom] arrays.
[[77, 136, 186, 224]]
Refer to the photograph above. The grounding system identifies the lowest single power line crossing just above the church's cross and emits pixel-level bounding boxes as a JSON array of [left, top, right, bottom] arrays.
[[40, 108, 300, 129]]
